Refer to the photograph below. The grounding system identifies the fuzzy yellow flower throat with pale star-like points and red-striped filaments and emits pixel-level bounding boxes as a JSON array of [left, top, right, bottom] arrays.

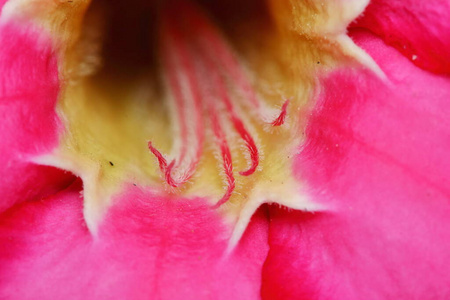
[[8, 0, 376, 244]]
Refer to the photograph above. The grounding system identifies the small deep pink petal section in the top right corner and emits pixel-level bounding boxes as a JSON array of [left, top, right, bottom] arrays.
[[352, 0, 450, 74]]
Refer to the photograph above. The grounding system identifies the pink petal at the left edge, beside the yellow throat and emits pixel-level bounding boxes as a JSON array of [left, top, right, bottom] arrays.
[[0, 24, 72, 212]]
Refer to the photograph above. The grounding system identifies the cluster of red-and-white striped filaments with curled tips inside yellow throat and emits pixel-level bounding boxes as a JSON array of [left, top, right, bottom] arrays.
[[148, 1, 289, 207]]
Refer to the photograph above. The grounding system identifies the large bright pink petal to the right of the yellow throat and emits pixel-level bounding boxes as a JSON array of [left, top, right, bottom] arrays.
[[262, 32, 450, 300]]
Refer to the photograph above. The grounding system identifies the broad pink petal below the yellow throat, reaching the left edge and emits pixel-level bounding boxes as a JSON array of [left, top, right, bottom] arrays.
[[0, 182, 268, 300]]
